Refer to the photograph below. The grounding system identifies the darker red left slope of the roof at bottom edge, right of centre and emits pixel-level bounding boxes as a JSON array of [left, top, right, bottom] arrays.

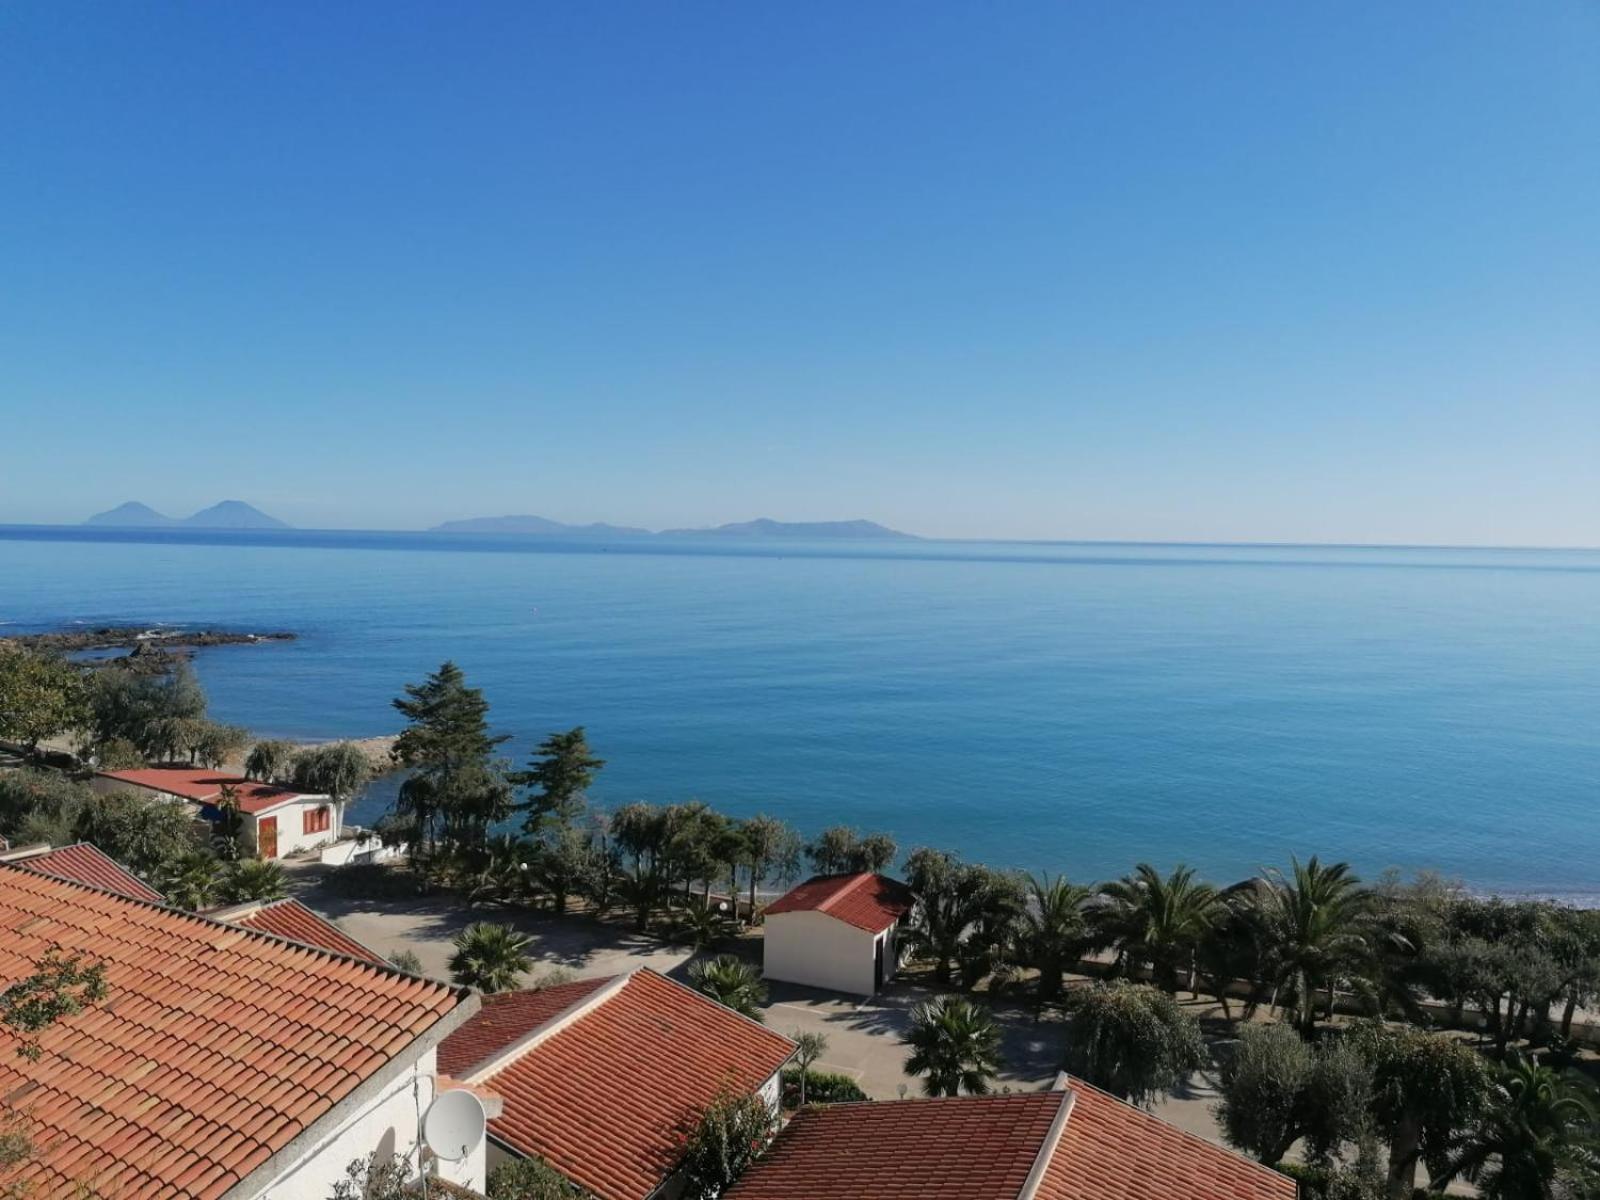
[[728, 1091, 1062, 1200]]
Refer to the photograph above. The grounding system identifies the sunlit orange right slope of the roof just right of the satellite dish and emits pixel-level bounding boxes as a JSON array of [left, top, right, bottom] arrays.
[[445, 970, 794, 1200]]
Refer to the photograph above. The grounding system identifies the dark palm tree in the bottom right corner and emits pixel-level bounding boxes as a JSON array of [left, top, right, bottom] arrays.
[[1432, 1050, 1600, 1200]]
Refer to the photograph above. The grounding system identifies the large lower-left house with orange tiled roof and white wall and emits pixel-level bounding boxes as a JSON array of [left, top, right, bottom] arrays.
[[0, 854, 486, 1200]]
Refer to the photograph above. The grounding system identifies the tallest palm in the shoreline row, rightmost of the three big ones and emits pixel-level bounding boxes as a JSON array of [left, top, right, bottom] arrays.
[[1254, 854, 1374, 1037]]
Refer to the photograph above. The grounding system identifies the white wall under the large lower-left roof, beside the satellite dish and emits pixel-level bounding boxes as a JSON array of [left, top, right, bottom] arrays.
[[253, 1050, 486, 1200]]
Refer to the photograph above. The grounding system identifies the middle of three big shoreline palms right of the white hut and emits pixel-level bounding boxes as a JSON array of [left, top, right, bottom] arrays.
[[1101, 862, 1221, 992]]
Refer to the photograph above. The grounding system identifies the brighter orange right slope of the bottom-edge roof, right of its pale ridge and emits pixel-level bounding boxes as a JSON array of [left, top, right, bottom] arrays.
[[1038, 1080, 1296, 1200]]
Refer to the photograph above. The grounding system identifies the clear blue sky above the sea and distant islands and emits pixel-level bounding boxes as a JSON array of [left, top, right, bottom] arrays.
[[0, 0, 1600, 544]]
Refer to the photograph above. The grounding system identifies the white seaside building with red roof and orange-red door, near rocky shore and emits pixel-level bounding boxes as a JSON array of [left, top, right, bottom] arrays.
[[93, 766, 344, 858]]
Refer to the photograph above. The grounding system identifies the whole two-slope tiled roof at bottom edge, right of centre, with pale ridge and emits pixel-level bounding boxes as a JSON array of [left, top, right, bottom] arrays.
[[726, 1080, 1294, 1200]]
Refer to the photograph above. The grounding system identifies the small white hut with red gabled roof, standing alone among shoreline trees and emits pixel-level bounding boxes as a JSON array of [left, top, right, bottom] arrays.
[[763, 872, 914, 995]]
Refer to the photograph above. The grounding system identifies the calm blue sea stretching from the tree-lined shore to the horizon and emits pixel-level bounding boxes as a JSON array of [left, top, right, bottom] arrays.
[[0, 528, 1600, 898]]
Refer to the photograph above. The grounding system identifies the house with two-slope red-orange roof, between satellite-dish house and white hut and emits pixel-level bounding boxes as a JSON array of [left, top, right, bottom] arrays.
[[438, 970, 795, 1200]]
